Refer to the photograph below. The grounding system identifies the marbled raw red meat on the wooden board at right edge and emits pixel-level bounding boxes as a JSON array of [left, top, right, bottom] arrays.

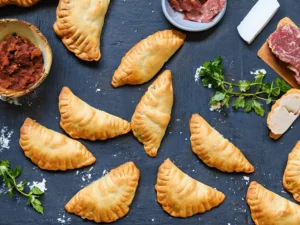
[[268, 24, 300, 83]]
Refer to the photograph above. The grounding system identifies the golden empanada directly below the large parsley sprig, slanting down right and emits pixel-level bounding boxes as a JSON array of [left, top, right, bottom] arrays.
[[190, 114, 254, 173]]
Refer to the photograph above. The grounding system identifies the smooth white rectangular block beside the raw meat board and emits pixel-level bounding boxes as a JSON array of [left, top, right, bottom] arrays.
[[237, 0, 280, 44]]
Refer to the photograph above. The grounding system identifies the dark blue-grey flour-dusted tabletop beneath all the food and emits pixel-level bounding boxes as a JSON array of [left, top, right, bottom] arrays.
[[0, 0, 300, 225]]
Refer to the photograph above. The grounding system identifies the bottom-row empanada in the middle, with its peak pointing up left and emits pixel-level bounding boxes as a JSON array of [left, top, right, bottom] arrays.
[[155, 159, 225, 218]]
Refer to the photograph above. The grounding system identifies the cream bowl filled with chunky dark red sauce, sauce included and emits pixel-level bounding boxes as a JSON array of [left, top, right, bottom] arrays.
[[0, 19, 52, 98]]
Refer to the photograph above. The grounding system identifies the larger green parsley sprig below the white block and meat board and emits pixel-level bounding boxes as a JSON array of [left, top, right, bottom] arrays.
[[198, 57, 290, 116]]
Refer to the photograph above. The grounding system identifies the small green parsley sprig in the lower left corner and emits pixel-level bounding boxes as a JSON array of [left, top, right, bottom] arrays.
[[0, 160, 44, 214]]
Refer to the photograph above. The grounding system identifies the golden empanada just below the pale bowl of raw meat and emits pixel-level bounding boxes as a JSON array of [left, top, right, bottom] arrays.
[[112, 30, 186, 87]]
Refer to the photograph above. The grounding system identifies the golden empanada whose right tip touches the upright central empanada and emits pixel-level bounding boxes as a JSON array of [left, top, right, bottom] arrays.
[[58, 87, 131, 141]]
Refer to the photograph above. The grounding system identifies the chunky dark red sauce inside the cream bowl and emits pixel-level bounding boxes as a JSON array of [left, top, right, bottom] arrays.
[[0, 34, 44, 91]]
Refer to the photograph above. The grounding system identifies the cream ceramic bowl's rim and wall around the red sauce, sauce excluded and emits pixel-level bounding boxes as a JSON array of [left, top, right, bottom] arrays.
[[0, 19, 52, 98]]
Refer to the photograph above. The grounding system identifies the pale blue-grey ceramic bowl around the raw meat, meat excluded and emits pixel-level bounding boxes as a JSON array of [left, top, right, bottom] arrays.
[[161, 0, 227, 32]]
